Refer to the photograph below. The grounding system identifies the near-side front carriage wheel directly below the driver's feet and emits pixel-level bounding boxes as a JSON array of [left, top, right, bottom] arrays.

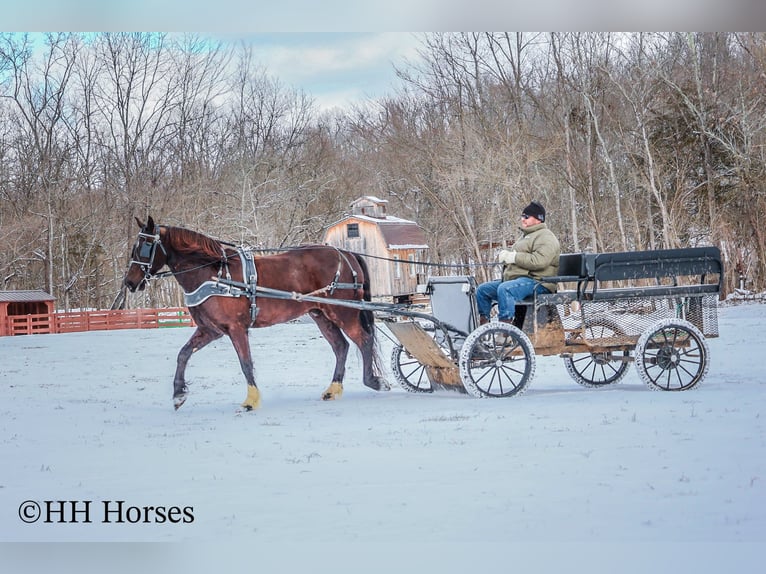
[[459, 322, 535, 397]]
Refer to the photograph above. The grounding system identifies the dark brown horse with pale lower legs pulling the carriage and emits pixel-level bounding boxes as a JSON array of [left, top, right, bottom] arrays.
[[124, 217, 390, 410]]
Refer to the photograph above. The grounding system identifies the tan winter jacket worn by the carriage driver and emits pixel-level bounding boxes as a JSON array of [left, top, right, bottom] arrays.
[[503, 223, 561, 293]]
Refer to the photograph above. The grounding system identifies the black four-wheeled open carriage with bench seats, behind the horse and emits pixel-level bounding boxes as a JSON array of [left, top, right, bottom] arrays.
[[387, 247, 723, 397]]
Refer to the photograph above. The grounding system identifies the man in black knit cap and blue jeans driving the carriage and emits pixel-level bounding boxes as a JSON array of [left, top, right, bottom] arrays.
[[476, 201, 561, 328]]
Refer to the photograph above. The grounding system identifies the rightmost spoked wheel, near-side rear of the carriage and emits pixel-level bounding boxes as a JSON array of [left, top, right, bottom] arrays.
[[636, 319, 710, 391]]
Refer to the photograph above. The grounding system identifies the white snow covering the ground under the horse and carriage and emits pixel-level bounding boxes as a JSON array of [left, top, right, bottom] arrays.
[[0, 304, 766, 572]]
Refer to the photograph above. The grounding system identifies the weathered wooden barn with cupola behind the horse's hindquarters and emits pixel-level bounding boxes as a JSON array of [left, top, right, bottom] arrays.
[[324, 195, 428, 301]]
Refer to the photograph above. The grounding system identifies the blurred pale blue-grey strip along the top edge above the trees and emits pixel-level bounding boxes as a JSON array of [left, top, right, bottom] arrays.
[[2, 0, 766, 33]]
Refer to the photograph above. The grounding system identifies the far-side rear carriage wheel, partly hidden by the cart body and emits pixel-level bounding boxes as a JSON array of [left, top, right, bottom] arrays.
[[564, 319, 630, 387]]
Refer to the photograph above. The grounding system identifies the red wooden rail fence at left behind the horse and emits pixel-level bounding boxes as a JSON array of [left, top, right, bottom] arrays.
[[0, 307, 194, 336]]
